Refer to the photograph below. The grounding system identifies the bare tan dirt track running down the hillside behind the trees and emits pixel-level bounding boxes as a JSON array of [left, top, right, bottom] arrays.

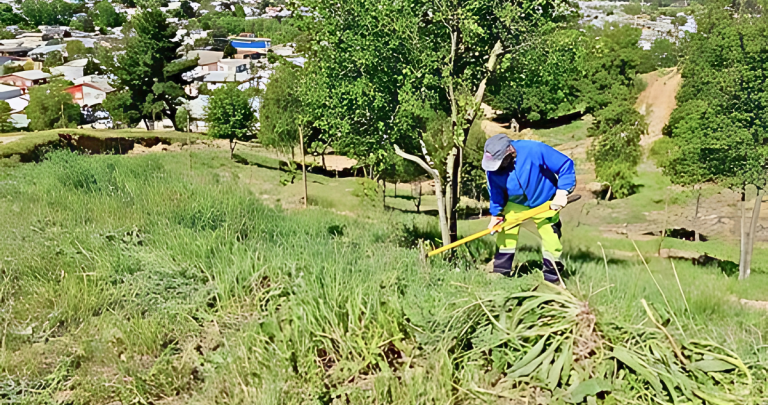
[[635, 68, 682, 146]]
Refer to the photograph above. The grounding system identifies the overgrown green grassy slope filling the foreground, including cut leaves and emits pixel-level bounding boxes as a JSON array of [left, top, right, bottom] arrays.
[[0, 151, 768, 404]]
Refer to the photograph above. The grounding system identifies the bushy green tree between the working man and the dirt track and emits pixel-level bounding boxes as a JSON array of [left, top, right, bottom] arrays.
[[588, 99, 647, 198]]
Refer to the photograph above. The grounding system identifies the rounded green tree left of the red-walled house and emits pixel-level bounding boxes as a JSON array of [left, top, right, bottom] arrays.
[[26, 80, 80, 131]]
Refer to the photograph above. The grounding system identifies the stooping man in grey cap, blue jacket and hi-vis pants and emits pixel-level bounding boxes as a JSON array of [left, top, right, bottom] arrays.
[[482, 134, 576, 283]]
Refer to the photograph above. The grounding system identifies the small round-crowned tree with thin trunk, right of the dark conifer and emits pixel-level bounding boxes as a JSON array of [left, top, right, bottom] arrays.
[[205, 83, 258, 159]]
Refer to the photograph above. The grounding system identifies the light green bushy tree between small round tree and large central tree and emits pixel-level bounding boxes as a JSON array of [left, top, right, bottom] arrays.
[[259, 64, 304, 153]]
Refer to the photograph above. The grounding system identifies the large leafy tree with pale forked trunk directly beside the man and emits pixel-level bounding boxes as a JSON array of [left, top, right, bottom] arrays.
[[294, 0, 571, 244]]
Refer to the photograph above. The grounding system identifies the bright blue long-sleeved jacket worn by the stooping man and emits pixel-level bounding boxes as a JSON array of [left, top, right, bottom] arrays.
[[486, 140, 576, 216]]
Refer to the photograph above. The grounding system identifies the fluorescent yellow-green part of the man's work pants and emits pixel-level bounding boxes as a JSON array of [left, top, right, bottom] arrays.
[[496, 202, 563, 261]]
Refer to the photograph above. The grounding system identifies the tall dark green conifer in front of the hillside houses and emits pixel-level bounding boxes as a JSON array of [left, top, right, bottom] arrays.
[[99, 9, 197, 129]]
